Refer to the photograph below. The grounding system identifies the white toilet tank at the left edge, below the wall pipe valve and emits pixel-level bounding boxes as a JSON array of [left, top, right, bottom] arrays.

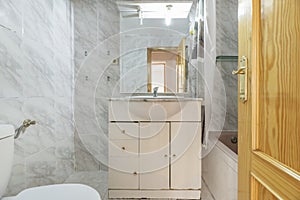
[[0, 124, 15, 199]]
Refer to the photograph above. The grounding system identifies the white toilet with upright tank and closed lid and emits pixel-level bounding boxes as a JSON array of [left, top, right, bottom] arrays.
[[0, 124, 101, 200]]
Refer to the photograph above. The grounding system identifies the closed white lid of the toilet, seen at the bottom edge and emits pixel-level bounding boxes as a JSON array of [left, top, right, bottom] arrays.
[[15, 184, 101, 200]]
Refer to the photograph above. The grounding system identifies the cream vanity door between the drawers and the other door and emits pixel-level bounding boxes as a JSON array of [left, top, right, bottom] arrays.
[[140, 122, 169, 189]]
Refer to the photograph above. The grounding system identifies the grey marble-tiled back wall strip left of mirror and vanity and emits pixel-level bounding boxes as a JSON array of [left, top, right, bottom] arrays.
[[73, 0, 120, 173]]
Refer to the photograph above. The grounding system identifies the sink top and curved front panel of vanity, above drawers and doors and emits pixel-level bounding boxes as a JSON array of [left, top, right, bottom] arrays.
[[109, 96, 202, 122]]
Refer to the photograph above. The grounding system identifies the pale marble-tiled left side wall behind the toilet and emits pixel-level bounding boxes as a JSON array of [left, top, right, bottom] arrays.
[[0, 0, 74, 195]]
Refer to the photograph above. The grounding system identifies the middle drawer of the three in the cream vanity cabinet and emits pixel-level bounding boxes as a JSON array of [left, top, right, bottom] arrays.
[[109, 139, 139, 157]]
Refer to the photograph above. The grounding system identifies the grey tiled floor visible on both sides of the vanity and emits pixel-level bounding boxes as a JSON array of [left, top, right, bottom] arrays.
[[66, 171, 214, 200]]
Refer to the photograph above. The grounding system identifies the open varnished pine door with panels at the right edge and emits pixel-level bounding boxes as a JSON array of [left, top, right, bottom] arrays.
[[238, 0, 300, 200]]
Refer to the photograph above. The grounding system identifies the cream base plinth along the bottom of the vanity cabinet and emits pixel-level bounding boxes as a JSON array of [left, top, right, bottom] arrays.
[[108, 190, 201, 199]]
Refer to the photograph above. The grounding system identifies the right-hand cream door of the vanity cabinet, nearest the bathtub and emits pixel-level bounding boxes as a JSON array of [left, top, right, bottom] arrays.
[[170, 122, 201, 189]]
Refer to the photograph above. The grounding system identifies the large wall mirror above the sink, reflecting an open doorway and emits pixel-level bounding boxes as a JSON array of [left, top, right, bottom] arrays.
[[117, 1, 193, 93]]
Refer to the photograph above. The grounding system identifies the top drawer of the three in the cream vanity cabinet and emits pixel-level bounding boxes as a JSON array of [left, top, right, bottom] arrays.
[[109, 123, 139, 140]]
